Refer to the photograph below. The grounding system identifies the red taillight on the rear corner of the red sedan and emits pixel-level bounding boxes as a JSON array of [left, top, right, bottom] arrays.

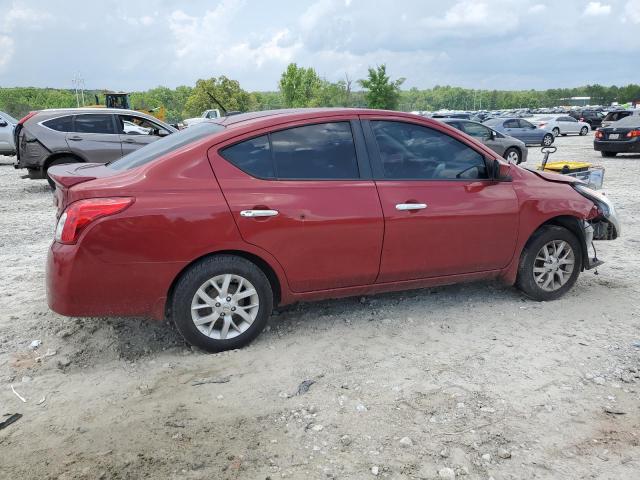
[[55, 197, 133, 243]]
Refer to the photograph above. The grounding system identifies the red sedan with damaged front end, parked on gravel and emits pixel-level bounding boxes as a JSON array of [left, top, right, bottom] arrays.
[[47, 109, 620, 351]]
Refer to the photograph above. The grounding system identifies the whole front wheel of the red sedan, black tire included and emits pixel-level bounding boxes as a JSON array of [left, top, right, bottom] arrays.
[[516, 225, 582, 301]]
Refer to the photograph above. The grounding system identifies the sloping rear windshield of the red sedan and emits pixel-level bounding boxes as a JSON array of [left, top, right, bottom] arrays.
[[107, 122, 224, 170]]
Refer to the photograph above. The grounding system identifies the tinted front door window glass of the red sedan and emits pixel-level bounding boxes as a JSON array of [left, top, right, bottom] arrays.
[[371, 120, 488, 180]]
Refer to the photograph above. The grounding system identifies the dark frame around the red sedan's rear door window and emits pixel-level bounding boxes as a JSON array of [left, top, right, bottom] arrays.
[[215, 117, 372, 182]]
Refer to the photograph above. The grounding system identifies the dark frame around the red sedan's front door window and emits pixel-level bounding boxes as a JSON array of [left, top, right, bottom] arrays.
[[360, 118, 493, 183]]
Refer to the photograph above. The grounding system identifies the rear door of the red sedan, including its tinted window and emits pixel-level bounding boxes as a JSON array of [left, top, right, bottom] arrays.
[[209, 117, 384, 292]]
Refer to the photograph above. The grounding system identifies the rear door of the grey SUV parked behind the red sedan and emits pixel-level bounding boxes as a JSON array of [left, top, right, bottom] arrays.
[[65, 113, 122, 163]]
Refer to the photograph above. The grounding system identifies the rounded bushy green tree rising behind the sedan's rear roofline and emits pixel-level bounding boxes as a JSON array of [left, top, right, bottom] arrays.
[[184, 75, 257, 117]]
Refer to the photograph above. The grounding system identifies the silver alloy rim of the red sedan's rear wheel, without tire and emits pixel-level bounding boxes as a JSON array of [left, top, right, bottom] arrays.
[[191, 274, 260, 340]]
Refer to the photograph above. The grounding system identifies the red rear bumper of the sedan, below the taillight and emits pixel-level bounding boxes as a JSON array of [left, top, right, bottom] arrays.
[[46, 242, 184, 320]]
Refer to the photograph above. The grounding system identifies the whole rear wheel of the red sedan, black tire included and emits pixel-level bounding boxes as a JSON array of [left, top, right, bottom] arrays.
[[171, 255, 273, 352]]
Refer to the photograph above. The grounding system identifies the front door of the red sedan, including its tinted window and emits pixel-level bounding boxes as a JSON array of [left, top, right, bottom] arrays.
[[363, 117, 519, 283]]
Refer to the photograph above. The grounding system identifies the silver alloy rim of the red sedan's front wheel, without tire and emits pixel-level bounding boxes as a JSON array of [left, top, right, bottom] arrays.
[[533, 240, 575, 292]]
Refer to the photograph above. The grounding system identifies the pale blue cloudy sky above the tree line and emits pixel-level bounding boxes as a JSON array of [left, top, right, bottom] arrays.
[[0, 0, 640, 91]]
